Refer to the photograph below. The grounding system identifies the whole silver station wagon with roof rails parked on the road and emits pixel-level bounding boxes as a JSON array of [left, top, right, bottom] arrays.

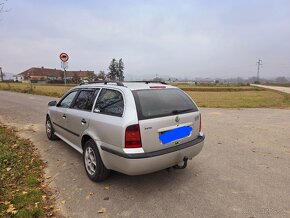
[[46, 81, 205, 181]]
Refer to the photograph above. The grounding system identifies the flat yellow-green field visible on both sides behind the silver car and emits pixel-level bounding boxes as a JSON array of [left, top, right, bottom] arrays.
[[0, 83, 290, 108]]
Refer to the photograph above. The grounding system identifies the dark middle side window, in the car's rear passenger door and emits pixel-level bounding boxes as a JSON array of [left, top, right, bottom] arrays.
[[72, 89, 99, 111]]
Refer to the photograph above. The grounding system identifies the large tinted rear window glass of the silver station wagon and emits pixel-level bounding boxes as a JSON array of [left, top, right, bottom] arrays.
[[133, 88, 198, 120]]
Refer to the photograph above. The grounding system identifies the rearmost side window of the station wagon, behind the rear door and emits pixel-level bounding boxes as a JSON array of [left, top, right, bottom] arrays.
[[94, 89, 124, 117]]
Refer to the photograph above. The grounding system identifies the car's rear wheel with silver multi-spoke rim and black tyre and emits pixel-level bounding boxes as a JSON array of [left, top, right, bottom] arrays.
[[83, 139, 110, 182]]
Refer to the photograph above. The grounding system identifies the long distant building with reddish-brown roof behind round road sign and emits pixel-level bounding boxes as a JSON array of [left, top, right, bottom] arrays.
[[14, 67, 95, 83]]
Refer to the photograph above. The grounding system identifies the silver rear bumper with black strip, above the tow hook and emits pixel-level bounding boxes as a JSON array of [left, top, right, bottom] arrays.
[[101, 135, 205, 175]]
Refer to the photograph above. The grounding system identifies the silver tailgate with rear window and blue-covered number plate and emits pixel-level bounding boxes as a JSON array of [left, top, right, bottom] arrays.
[[133, 88, 200, 152]]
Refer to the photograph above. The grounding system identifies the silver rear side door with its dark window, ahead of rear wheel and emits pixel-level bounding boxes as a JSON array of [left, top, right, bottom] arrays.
[[66, 89, 100, 148]]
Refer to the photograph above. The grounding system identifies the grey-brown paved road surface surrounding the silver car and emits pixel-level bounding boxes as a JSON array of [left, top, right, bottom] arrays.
[[0, 91, 290, 217]]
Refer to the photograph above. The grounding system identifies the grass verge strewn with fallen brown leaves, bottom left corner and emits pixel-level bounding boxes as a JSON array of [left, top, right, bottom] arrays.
[[0, 124, 54, 217]]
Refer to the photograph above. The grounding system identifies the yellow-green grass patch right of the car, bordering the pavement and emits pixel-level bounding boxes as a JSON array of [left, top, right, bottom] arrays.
[[187, 91, 290, 108]]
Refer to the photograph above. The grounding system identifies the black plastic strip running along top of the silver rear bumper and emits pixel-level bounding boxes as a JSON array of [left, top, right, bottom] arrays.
[[101, 135, 205, 159]]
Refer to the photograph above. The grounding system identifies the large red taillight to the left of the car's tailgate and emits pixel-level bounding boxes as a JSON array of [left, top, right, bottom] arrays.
[[125, 124, 142, 148]]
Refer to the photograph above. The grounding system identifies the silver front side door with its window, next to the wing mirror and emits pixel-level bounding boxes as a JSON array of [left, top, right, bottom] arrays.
[[50, 90, 78, 137]]
